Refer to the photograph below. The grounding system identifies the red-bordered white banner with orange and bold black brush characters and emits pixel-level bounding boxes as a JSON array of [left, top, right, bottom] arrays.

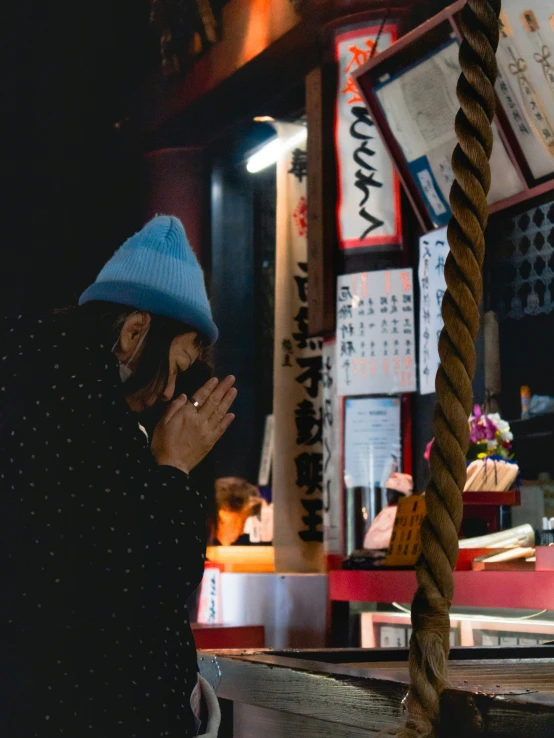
[[335, 24, 402, 249]]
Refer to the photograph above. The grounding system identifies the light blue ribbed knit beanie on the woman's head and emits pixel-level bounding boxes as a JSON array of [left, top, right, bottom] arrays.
[[79, 215, 218, 344]]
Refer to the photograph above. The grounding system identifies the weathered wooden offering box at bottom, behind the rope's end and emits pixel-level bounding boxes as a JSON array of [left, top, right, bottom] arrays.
[[199, 646, 554, 738]]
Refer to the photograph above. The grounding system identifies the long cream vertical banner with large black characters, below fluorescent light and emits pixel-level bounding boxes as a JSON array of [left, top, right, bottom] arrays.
[[272, 123, 324, 572]]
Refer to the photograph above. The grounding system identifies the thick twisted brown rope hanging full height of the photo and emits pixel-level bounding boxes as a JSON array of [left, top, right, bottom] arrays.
[[399, 0, 500, 738]]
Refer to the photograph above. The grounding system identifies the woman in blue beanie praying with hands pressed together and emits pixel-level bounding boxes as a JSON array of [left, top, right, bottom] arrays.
[[0, 216, 236, 738]]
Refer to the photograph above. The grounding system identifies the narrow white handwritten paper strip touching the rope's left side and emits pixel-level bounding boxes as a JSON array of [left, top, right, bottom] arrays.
[[419, 228, 449, 395]]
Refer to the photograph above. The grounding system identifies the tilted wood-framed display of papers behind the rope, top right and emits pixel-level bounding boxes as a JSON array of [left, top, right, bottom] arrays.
[[354, 0, 554, 231]]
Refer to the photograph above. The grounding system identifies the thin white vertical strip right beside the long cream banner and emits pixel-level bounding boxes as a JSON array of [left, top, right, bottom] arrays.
[[323, 340, 344, 554]]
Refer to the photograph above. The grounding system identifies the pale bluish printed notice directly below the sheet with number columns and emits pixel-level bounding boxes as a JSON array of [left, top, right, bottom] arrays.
[[344, 397, 401, 489]]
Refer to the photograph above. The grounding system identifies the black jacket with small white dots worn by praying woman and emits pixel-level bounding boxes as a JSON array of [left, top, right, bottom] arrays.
[[0, 318, 206, 738]]
